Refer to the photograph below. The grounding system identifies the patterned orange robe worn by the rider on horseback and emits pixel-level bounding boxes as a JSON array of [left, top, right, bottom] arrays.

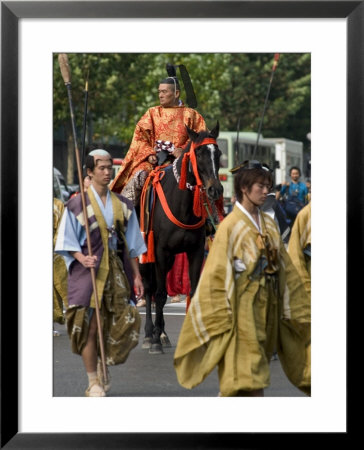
[[110, 105, 206, 193]]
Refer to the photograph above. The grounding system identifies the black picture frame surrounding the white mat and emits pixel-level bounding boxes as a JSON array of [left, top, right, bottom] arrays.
[[1, 0, 358, 449]]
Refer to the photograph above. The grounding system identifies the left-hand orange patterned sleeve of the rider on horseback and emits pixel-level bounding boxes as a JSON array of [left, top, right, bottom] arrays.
[[110, 110, 155, 193]]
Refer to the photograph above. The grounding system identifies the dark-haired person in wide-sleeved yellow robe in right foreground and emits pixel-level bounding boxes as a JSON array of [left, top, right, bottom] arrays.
[[174, 161, 311, 397]]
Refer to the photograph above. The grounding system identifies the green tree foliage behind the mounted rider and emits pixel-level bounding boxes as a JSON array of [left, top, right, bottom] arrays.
[[53, 53, 311, 155]]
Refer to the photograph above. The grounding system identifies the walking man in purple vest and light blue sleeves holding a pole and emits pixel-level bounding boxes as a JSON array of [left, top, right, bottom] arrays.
[[55, 149, 146, 397]]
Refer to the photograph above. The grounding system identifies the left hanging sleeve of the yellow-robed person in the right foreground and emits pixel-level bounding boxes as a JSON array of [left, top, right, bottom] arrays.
[[174, 222, 235, 389]]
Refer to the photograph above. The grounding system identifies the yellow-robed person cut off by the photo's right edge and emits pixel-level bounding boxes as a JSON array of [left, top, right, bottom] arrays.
[[288, 202, 311, 295]]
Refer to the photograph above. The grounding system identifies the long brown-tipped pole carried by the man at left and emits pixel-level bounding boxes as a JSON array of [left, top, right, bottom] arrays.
[[58, 53, 108, 384]]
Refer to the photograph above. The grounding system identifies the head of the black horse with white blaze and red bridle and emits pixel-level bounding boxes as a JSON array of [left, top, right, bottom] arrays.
[[186, 122, 223, 201]]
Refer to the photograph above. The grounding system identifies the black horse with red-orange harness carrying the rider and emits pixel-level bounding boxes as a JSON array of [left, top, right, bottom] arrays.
[[143, 123, 223, 353]]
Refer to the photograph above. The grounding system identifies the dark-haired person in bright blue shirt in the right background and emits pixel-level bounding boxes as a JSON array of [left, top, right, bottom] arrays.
[[276, 167, 308, 225]]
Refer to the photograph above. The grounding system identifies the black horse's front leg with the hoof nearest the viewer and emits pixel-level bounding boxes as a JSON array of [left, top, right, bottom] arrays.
[[149, 250, 174, 353]]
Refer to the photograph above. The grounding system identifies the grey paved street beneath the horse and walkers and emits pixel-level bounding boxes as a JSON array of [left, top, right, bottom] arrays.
[[53, 300, 304, 397]]
